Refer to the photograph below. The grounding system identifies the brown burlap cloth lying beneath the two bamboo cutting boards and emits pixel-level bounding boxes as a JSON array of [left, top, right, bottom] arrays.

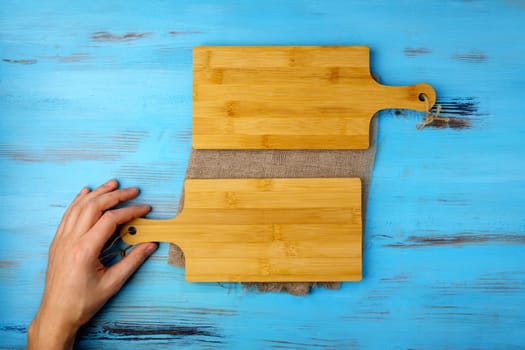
[[168, 116, 377, 295]]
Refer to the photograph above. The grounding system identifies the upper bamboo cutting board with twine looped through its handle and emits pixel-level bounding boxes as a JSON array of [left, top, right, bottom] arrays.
[[193, 46, 436, 149]]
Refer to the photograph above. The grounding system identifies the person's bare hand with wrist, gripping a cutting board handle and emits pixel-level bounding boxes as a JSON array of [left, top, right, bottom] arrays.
[[27, 180, 157, 349]]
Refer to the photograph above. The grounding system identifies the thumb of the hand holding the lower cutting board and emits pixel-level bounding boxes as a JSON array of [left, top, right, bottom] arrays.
[[104, 242, 158, 295]]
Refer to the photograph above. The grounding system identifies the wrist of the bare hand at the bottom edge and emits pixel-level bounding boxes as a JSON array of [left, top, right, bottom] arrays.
[[27, 313, 78, 350]]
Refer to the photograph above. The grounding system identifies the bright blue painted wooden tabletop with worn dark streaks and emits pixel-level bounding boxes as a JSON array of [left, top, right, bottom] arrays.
[[0, 0, 525, 349]]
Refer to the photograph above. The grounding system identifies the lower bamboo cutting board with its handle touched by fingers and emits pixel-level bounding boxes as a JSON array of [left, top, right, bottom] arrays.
[[120, 178, 362, 282]]
